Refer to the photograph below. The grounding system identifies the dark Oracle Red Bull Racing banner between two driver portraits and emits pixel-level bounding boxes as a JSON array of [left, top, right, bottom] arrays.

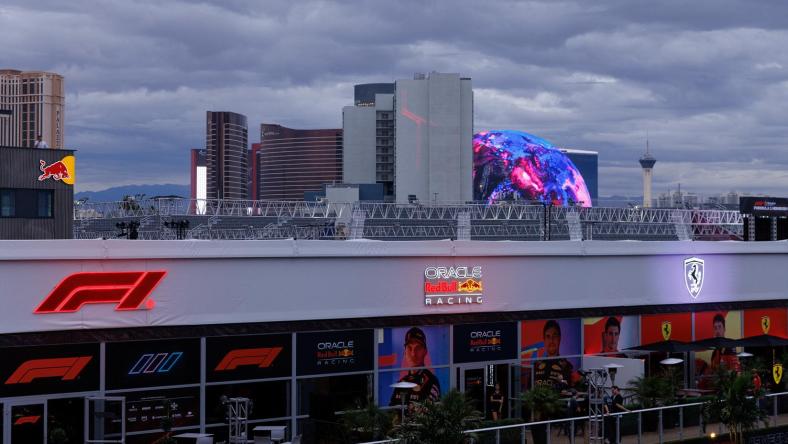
[[454, 322, 517, 363]]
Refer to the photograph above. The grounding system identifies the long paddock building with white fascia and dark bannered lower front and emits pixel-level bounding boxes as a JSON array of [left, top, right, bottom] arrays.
[[0, 240, 788, 444]]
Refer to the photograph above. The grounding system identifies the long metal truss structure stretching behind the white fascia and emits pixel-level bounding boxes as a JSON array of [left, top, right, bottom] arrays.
[[74, 199, 743, 241]]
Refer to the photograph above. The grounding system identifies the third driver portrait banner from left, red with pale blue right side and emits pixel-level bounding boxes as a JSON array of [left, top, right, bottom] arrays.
[[583, 316, 639, 357]]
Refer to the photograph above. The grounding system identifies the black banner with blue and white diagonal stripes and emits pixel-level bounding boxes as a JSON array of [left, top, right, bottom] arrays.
[[106, 339, 200, 390]]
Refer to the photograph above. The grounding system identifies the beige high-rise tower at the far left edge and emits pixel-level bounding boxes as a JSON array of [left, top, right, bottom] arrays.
[[0, 69, 66, 148]]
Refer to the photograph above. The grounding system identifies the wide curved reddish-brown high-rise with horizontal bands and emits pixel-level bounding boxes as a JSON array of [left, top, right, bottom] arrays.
[[254, 123, 342, 200]]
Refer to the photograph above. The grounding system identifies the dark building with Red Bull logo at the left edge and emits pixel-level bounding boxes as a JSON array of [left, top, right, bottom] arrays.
[[0, 146, 76, 239]]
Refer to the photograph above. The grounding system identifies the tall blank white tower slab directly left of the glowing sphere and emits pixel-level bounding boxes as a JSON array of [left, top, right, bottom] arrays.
[[395, 72, 473, 203]]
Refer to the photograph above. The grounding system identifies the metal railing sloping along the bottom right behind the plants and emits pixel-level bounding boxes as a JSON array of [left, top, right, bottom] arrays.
[[356, 392, 788, 444]]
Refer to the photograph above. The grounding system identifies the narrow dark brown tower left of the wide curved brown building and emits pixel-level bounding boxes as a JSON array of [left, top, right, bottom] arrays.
[[205, 111, 249, 199]]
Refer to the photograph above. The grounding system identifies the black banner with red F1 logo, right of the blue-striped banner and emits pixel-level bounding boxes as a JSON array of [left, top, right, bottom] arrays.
[[205, 334, 292, 382]]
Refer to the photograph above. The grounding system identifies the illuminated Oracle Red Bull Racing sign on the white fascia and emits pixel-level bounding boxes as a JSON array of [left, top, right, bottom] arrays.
[[424, 265, 484, 305]]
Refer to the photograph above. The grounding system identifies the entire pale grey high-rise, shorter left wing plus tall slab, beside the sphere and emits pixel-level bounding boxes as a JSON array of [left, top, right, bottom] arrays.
[[342, 72, 473, 203]]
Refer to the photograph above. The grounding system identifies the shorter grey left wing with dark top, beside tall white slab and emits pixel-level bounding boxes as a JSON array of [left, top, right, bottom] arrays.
[[342, 83, 396, 200]]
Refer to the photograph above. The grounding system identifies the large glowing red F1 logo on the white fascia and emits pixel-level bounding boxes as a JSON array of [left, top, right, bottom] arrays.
[[33, 271, 167, 314]]
